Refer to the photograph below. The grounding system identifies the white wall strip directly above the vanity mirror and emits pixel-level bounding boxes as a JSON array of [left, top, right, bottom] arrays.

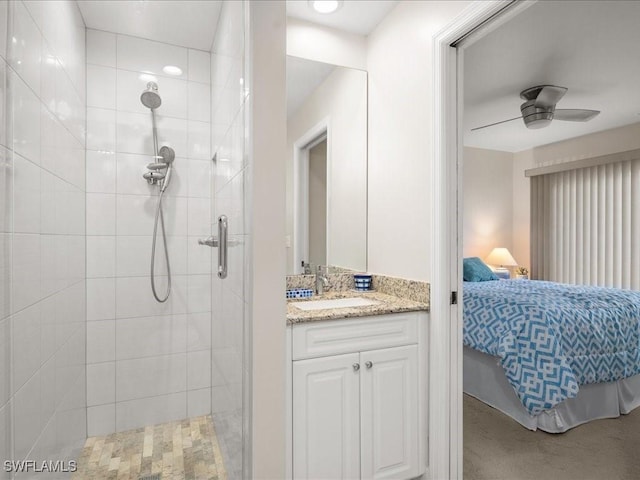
[[287, 17, 367, 70]]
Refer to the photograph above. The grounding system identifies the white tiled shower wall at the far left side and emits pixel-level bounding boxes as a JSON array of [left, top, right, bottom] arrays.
[[0, 1, 86, 472]]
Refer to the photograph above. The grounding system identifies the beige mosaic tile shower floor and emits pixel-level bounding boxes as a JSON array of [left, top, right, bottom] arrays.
[[73, 415, 227, 480]]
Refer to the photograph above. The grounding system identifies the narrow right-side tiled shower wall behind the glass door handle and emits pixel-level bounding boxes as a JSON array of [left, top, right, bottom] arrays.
[[211, 2, 251, 479]]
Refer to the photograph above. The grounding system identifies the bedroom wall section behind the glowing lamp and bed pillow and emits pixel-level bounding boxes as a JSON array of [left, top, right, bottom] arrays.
[[462, 147, 516, 265]]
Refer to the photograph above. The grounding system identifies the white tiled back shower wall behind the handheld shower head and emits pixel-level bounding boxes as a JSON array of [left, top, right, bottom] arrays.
[[87, 26, 214, 435]]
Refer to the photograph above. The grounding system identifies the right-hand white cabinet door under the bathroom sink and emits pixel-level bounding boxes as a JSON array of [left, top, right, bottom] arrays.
[[360, 345, 420, 479]]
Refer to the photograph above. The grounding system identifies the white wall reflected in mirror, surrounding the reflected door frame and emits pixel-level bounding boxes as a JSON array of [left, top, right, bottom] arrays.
[[287, 68, 367, 272]]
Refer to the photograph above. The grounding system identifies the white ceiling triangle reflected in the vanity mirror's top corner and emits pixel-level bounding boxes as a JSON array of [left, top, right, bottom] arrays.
[[287, 56, 336, 117]]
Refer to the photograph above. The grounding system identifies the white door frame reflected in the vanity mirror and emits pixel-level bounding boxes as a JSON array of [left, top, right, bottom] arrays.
[[293, 117, 331, 274]]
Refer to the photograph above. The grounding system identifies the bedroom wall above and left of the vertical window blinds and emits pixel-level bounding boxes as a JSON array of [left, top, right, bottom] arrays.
[[512, 123, 640, 272]]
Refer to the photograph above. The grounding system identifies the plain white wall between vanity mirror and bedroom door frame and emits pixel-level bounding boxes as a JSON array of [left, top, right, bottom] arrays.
[[367, 1, 470, 281]]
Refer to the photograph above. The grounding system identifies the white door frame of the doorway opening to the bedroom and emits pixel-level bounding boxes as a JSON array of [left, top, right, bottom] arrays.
[[428, 0, 536, 480]]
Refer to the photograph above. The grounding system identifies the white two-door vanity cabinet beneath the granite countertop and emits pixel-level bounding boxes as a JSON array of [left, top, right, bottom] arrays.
[[291, 312, 424, 480]]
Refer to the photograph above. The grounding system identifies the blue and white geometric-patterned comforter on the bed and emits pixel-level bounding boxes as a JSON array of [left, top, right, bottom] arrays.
[[463, 280, 640, 415]]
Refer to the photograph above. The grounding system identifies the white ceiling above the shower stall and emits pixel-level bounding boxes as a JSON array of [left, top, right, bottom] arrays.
[[78, 0, 222, 51]]
